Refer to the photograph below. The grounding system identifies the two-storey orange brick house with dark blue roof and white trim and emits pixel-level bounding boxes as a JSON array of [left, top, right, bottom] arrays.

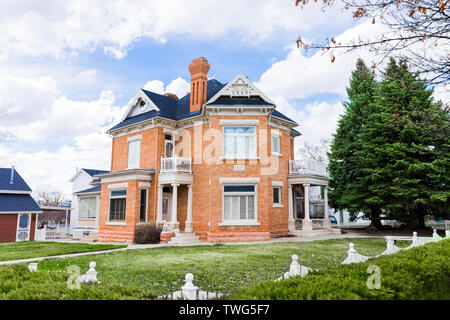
[[95, 57, 330, 242]]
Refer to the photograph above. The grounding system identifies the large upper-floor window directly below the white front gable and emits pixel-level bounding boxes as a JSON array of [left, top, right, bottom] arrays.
[[223, 127, 256, 159]]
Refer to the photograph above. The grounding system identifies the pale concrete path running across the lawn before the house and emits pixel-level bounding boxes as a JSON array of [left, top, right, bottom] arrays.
[[0, 233, 372, 266]]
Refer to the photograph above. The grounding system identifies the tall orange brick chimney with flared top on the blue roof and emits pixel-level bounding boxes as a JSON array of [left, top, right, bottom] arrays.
[[189, 57, 210, 112]]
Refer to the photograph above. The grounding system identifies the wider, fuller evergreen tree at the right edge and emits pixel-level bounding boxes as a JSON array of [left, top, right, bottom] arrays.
[[356, 59, 450, 226]]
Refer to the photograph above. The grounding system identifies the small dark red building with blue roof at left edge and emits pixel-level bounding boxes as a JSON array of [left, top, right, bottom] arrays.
[[0, 168, 42, 242]]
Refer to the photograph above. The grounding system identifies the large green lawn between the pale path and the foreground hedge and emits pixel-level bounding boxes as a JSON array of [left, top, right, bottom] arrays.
[[0, 239, 394, 299]]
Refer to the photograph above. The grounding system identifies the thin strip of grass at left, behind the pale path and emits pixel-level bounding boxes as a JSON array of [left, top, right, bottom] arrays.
[[0, 241, 126, 261]]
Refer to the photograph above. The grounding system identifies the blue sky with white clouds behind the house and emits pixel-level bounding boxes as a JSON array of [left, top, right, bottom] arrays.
[[0, 0, 442, 197]]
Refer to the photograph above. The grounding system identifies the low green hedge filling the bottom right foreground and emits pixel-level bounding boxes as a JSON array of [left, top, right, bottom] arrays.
[[231, 239, 450, 300]]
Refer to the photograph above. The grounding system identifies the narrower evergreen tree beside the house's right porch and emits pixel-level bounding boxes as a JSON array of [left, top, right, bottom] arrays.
[[328, 59, 379, 225]]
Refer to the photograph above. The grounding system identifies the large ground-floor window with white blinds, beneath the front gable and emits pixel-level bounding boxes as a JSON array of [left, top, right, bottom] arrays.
[[223, 185, 256, 222]]
